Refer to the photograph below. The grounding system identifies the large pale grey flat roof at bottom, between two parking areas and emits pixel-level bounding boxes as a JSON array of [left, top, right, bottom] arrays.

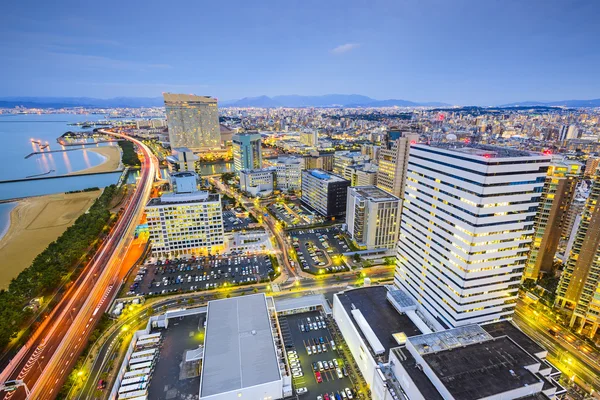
[[200, 294, 281, 397]]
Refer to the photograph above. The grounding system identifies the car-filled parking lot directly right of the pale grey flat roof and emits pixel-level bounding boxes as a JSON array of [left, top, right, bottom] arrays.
[[279, 311, 354, 400]]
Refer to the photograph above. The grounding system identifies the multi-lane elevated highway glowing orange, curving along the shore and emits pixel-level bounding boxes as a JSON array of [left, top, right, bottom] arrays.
[[2, 133, 157, 400]]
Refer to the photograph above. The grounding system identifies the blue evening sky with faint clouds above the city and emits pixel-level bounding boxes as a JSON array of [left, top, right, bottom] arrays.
[[0, 0, 600, 105]]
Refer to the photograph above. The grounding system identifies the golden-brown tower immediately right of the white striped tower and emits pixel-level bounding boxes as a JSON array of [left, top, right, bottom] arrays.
[[523, 160, 583, 280]]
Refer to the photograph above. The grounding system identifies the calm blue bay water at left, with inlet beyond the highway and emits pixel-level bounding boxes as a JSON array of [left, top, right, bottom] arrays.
[[0, 114, 233, 234]]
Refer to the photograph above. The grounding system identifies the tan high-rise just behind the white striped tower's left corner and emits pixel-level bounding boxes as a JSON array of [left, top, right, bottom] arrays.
[[377, 130, 419, 199]]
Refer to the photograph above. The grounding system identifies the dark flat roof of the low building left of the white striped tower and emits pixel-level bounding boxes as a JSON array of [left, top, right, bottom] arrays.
[[335, 286, 421, 362]]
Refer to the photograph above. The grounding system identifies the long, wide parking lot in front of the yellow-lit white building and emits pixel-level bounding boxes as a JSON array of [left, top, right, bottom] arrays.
[[127, 252, 273, 296]]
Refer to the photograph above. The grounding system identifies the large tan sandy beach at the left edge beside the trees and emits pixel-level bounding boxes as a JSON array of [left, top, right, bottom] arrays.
[[0, 191, 101, 289]]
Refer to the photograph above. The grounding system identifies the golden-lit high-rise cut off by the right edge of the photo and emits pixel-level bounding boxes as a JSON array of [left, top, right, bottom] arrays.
[[556, 176, 600, 337]]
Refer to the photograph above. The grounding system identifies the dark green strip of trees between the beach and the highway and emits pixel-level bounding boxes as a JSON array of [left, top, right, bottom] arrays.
[[0, 185, 118, 348]]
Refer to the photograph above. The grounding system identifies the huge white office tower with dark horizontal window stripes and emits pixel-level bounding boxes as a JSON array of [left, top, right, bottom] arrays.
[[395, 142, 551, 329]]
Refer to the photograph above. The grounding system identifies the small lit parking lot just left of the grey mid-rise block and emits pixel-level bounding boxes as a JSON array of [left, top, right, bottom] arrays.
[[290, 227, 349, 274]]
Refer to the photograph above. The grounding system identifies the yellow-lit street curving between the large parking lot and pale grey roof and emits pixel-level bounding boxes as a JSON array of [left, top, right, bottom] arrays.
[[75, 266, 395, 400]]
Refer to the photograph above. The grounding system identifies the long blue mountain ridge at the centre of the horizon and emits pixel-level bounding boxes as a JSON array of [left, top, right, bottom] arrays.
[[220, 94, 450, 107]]
